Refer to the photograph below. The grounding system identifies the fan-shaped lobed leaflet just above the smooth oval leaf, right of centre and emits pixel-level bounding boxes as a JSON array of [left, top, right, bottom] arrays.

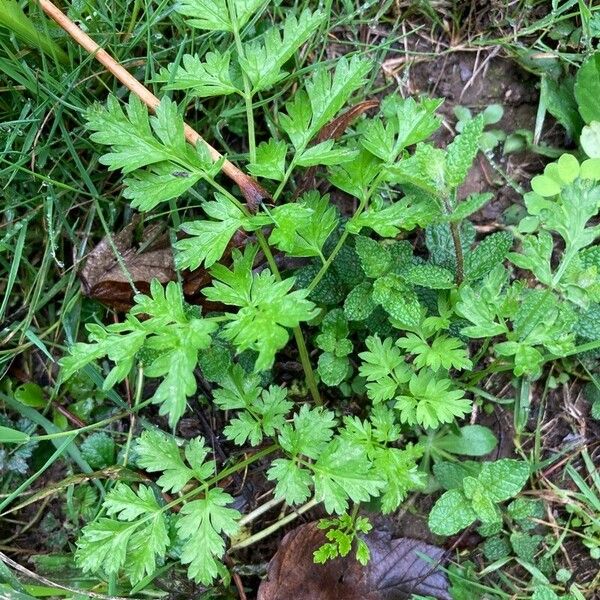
[[395, 369, 471, 429]]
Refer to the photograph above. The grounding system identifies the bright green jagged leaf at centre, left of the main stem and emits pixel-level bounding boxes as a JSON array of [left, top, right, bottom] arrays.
[[203, 249, 317, 371]]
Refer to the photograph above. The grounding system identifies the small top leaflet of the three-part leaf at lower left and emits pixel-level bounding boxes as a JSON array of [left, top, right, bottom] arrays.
[[137, 430, 215, 492]]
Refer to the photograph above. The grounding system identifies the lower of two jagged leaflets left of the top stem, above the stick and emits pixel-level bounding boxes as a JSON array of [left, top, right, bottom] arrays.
[[154, 51, 239, 98]]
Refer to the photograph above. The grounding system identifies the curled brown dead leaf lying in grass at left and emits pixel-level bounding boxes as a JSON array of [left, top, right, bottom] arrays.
[[80, 215, 176, 310]]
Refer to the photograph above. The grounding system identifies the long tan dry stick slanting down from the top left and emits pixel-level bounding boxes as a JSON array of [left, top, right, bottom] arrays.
[[38, 0, 269, 212]]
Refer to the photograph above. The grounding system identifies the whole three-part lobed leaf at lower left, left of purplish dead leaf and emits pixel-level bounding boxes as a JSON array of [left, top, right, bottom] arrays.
[[76, 431, 240, 585]]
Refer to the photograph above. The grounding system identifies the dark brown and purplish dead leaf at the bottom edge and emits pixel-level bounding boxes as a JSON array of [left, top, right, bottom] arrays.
[[257, 523, 451, 600]]
